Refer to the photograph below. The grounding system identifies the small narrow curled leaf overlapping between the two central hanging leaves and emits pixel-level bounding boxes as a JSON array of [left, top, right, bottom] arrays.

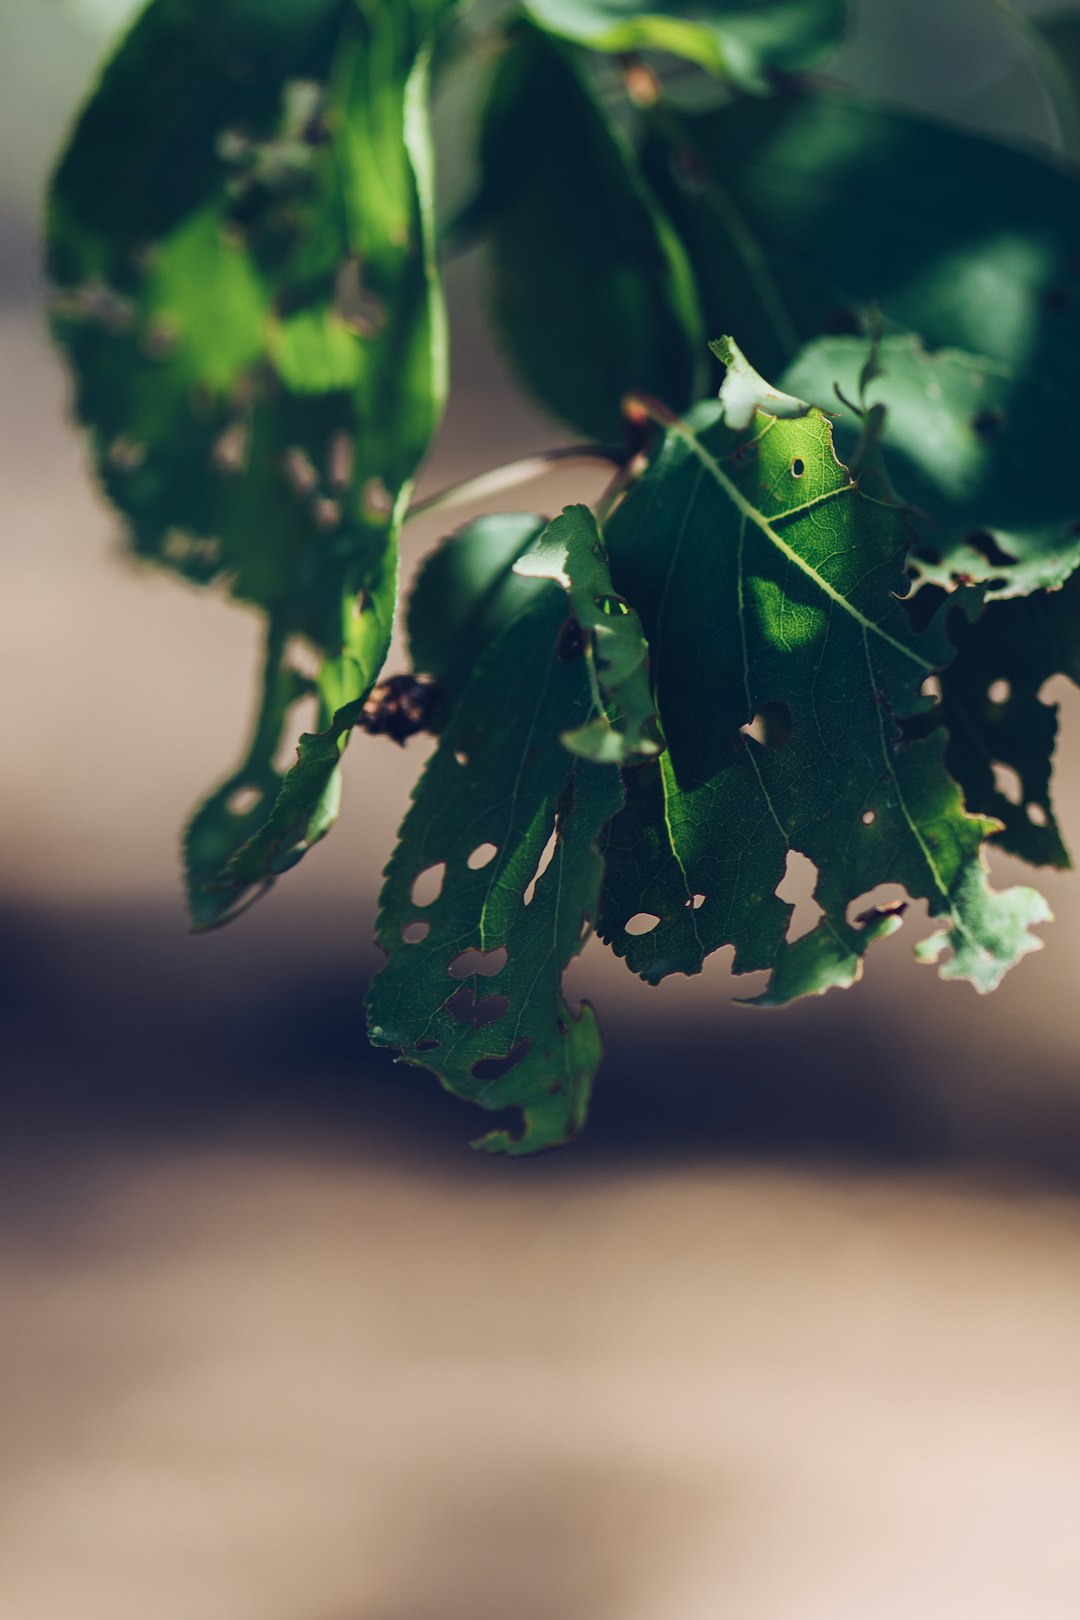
[[513, 505, 664, 765]]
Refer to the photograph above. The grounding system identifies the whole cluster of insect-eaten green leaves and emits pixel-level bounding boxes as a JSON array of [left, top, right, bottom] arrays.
[[49, 0, 1080, 1153]]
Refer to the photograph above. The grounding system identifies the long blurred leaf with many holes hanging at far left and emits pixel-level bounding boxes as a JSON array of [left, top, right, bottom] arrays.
[[49, 0, 445, 925]]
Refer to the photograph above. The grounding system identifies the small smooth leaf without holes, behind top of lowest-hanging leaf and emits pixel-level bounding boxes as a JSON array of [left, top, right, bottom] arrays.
[[406, 512, 546, 710]]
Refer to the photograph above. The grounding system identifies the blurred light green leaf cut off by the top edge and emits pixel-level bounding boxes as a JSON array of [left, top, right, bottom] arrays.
[[528, 0, 847, 91]]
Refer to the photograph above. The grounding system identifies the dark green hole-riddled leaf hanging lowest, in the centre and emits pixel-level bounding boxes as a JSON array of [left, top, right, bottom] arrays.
[[368, 586, 622, 1153]]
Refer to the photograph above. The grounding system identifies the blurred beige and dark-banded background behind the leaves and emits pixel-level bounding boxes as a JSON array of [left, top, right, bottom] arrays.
[[0, 0, 1080, 1620]]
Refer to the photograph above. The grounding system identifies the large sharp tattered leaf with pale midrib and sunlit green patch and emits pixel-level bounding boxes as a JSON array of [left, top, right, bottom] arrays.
[[599, 341, 1049, 1003]]
